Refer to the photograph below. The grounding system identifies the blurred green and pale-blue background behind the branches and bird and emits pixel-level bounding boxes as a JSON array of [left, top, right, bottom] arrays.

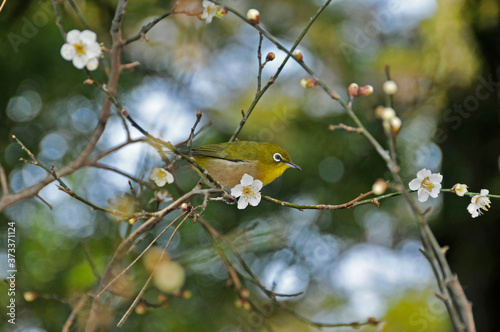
[[0, 0, 500, 332]]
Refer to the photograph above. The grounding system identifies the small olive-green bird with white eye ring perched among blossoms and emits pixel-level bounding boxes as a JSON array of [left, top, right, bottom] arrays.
[[192, 141, 301, 188]]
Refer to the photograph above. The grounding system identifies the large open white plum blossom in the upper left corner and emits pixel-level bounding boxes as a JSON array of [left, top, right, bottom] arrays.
[[61, 30, 101, 70]]
